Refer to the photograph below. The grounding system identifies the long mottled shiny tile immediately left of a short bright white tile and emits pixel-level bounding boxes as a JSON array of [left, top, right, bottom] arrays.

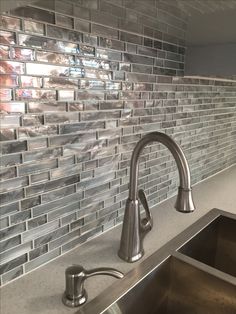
[[16, 89, 56, 100]]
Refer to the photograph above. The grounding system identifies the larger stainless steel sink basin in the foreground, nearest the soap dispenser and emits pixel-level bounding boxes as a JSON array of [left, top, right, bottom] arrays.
[[104, 256, 236, 314]]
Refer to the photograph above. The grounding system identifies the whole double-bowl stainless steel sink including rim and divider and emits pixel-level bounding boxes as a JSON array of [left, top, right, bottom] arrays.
[[77, 209, 236, 314]]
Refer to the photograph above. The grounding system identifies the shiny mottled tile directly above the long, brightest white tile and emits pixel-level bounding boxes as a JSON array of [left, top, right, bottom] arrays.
[[37, 51, 75, 65]]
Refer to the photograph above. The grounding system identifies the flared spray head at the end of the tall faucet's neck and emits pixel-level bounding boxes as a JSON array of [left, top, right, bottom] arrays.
[[175, 187, 195, 213]]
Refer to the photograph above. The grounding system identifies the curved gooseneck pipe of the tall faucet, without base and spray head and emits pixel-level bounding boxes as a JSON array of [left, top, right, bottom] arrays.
[[129, 132, 191, 200]]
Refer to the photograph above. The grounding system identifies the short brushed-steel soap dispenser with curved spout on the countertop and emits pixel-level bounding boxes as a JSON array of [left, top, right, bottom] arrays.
[[62, 265, 124, 307]]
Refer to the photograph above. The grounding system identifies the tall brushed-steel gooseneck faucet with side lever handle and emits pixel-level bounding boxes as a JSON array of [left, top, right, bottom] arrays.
[[118, 132, 195, 263]]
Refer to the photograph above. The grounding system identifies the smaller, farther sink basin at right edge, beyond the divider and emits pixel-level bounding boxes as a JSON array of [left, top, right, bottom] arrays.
[[179, 216, 236, 277]]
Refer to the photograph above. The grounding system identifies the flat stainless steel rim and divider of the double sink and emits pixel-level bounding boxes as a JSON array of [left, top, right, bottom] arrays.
[[76, 208, 236, 314]]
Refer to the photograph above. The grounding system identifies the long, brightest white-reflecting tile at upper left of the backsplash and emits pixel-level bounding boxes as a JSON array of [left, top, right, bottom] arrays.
[[26, 63, 69, 76]]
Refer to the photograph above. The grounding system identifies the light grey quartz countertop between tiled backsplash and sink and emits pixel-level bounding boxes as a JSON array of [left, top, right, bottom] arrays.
[[0, 166, 236, 314]]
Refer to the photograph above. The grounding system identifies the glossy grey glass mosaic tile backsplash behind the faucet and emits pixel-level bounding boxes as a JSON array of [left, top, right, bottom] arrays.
[[0, 0, 236, 285]]
